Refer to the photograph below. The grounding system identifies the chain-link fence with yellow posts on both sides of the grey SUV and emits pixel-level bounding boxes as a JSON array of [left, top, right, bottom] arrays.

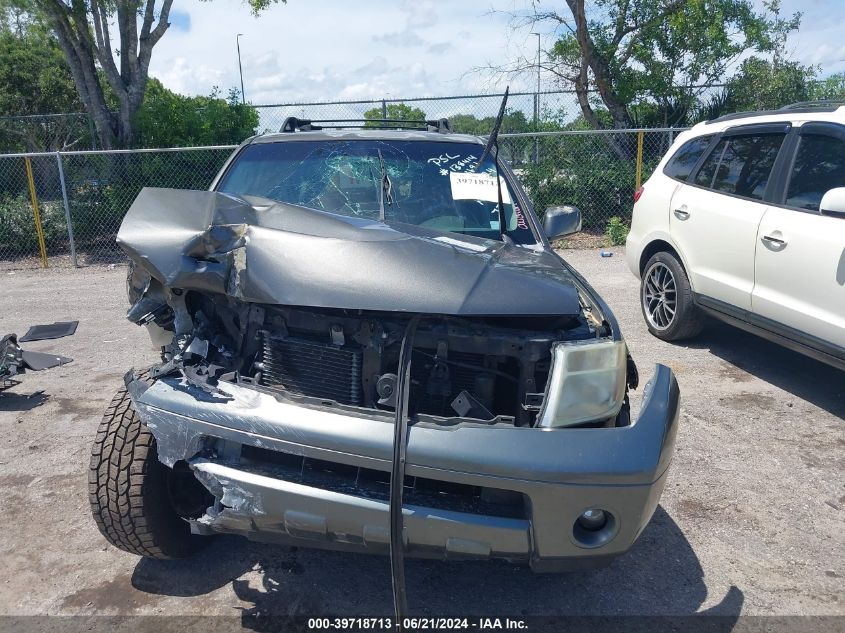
[[0, 129, 680, 270]]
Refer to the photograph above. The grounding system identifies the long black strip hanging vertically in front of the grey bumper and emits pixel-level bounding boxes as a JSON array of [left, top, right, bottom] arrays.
[[390, 315, 420, 631]]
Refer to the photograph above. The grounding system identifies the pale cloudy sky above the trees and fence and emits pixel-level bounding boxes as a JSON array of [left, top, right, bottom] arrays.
[[150, 0, 845, 104]]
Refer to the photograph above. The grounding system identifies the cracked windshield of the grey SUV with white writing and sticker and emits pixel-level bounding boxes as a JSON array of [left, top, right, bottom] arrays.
[[217, 140, 535, 244]]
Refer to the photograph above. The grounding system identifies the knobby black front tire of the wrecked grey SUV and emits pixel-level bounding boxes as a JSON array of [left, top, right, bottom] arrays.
[[88, 378, 213, 559]]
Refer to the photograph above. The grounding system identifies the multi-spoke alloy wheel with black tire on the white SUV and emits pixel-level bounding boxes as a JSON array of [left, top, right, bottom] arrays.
[[640, 252, 705, 341]]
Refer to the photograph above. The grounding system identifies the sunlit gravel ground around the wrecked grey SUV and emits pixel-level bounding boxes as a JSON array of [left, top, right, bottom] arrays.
[[0, 250, 845, 625]]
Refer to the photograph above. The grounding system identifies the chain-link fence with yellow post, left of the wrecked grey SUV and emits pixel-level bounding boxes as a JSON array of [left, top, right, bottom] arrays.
[[0, 146, 234, 269]]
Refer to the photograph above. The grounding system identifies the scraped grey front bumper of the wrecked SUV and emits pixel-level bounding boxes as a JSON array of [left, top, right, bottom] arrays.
[[128, 365, 679, 571]]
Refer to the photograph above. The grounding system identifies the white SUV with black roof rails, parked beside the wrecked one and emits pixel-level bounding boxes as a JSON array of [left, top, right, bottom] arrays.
[[626, 103, 845, 369]]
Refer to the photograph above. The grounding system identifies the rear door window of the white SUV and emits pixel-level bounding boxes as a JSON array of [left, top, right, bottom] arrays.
[[695, 134, 784, 200]]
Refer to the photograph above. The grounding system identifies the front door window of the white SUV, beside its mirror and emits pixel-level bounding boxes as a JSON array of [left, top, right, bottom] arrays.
[[786, 134, 845, 211]]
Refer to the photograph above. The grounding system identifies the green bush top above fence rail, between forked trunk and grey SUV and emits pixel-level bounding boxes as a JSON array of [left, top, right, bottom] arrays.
[[135, 78, 258, 147]]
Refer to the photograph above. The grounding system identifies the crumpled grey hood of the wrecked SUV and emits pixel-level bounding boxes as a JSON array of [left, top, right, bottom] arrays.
[[117, 188, 580, 316]]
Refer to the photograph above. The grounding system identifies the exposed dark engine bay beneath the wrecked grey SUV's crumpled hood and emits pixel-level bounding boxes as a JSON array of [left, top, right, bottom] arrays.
[[129, 280, 597, 426]]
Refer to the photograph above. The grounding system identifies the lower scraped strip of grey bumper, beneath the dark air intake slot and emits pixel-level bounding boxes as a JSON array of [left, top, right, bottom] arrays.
[[191, 459, 531, 561]]
